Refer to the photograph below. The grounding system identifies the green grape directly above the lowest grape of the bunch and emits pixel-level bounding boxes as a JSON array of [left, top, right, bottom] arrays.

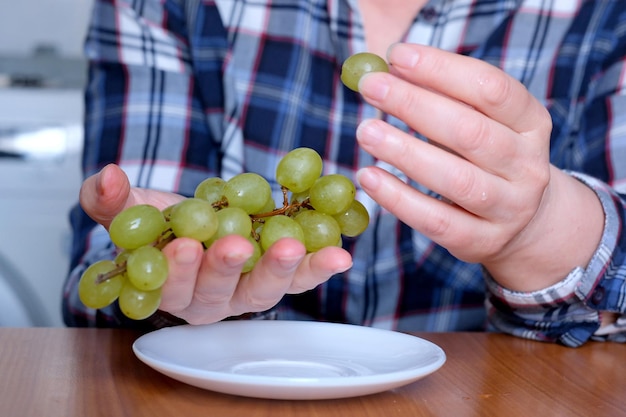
[[126, 246, 168, 291]]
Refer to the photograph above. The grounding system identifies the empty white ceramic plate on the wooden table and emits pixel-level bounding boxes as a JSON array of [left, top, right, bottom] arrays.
[[133, 320, 446, 400]]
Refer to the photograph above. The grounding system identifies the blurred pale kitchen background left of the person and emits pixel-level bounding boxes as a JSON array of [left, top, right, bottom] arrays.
[[0, 0, 92, 327]]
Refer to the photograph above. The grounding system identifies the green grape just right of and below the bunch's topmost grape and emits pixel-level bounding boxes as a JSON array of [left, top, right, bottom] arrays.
[[309, 174, 356, 215]]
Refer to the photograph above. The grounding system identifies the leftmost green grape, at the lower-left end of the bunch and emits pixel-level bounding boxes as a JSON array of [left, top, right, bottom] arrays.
[[78, 260, 125, 309]]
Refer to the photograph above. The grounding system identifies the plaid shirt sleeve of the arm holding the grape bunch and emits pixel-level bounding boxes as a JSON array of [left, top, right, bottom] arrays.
[[63, 0, 211, 327]]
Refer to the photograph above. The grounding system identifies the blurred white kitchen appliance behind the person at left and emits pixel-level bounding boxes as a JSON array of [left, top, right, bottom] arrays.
[[0, 88, 82, 326]]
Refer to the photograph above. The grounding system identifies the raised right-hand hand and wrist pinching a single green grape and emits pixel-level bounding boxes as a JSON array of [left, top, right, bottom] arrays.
[[357, 44, 603, 290]]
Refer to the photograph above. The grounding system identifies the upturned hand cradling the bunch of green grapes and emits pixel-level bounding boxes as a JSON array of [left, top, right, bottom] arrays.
[[80, 165, 352, 324]]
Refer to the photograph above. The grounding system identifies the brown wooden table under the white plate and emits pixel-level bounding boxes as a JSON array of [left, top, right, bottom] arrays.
[[0, 328, 626, 417]]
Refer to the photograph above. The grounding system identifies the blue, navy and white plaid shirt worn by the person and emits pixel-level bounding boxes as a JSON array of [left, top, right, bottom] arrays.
[[64, 0, 626, 346]]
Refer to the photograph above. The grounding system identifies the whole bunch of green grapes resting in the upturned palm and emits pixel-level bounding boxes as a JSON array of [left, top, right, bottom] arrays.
[[78, 148, 369, 320]]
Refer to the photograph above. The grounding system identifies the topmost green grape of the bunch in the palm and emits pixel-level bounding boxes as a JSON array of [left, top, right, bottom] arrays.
[[276, 148, 322, 193]]
